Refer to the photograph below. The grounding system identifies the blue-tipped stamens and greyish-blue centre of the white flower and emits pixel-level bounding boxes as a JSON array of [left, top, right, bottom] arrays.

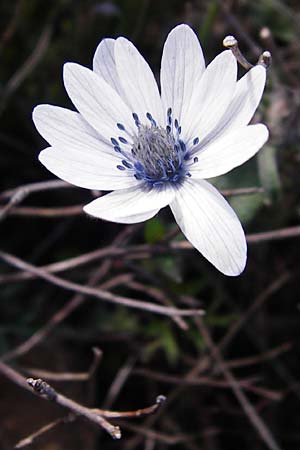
[[111, 108, 199, 187]]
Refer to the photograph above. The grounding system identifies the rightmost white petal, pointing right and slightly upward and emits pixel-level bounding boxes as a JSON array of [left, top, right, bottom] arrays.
[[190, 124, 269, 178]]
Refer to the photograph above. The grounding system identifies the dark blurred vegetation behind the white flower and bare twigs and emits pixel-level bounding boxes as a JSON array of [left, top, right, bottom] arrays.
[[0, 0, 300, 450]]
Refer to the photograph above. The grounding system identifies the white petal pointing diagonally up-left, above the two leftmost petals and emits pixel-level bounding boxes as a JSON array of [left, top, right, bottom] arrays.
[[64, 63, 134, 141]]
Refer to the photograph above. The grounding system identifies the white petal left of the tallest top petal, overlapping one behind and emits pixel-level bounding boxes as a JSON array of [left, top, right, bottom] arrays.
[[115, 37, 163, 124]]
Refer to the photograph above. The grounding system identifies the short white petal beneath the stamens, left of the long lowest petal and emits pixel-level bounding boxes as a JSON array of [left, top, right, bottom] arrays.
[[84, 187, 175, 223]]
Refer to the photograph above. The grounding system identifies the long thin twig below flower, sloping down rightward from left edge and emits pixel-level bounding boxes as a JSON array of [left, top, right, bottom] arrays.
[[0, 251, 203, 317]]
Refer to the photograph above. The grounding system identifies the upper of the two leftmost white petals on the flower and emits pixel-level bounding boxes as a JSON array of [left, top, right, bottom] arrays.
[[32, 105, 121, 158]]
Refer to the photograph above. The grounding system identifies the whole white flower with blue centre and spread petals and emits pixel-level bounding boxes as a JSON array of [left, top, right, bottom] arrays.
[[33, 25, 268, 276]]
